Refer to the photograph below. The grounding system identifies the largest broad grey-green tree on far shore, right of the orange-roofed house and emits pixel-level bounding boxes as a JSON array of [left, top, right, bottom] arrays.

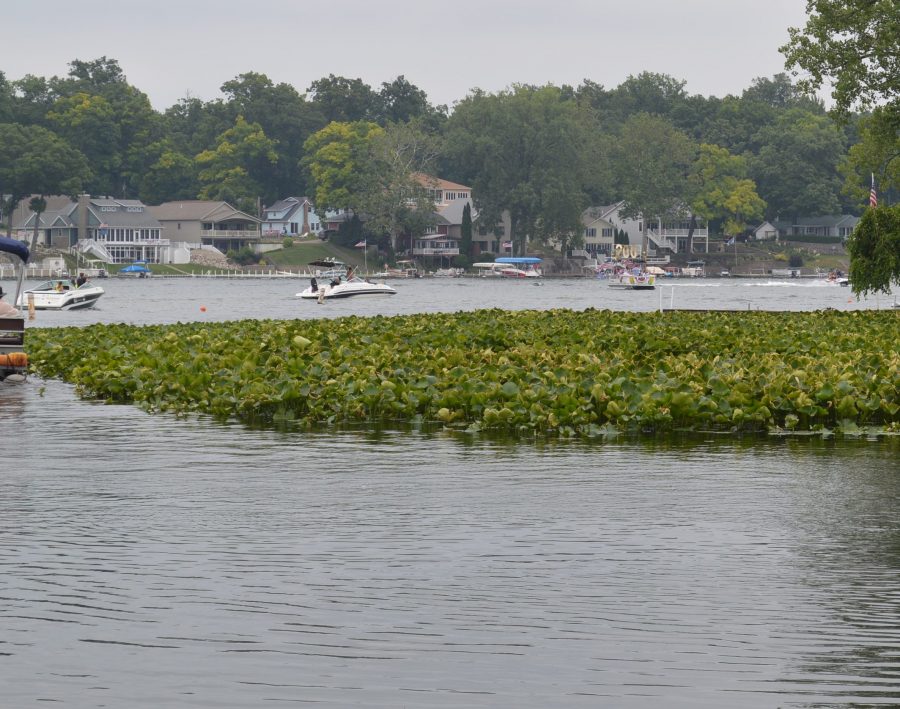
[[445, 86, 596, 255]]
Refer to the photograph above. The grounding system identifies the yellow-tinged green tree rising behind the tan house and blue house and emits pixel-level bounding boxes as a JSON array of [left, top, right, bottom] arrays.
[[195, 116, 278, 214]]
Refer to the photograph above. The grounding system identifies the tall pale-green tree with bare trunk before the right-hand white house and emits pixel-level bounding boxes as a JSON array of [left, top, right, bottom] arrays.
[[612, 114, 696, 255]]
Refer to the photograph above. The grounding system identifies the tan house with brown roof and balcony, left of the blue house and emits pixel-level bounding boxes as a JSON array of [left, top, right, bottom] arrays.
[[148, 200, 262, 254]]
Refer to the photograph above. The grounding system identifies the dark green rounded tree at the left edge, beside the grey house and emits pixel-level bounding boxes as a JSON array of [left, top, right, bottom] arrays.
[[0, 123, 91, 234]]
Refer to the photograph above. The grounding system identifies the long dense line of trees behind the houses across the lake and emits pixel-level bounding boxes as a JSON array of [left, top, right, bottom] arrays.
[[0, 0, 900, 266]]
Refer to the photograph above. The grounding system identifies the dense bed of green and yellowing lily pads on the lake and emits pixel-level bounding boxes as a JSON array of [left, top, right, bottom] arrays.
[[27, 310, 900, 437]]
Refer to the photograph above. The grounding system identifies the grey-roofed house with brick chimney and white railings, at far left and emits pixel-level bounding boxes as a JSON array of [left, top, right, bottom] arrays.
[[15, 194, 169, 263]]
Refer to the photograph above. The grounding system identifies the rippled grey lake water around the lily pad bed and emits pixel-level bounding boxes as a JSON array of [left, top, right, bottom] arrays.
[[0, 279, 900, 709]]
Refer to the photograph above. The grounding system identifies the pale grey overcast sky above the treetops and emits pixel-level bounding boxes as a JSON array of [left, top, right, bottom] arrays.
[[0, 0, 806, 110]]
